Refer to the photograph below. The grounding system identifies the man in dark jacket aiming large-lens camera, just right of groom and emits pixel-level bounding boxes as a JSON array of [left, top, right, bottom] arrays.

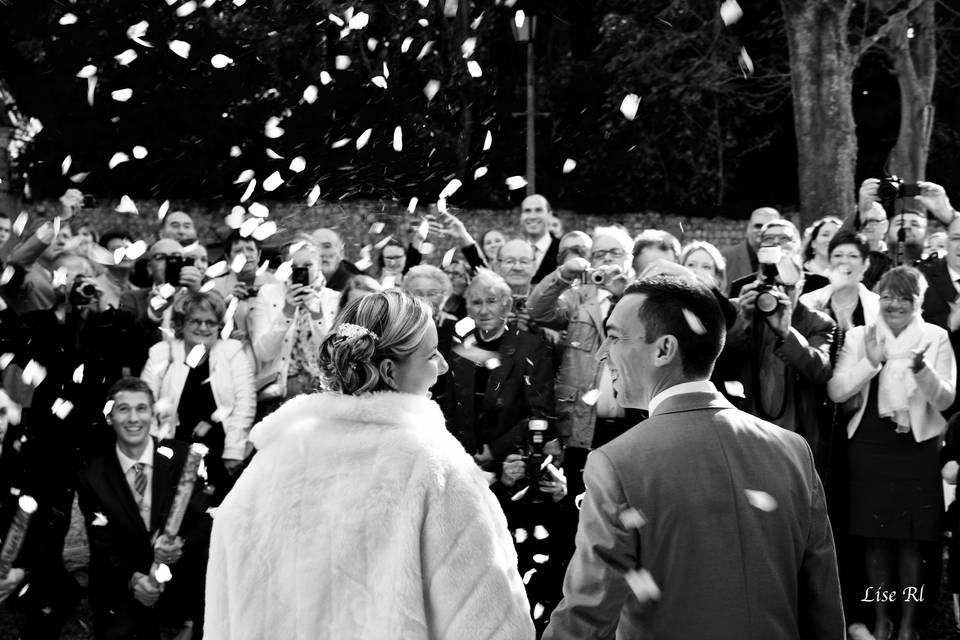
[[723, 220, 835, 463]]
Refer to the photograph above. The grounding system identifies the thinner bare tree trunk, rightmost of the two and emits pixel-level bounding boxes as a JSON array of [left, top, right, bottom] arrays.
[[886, 0, 937, 182]]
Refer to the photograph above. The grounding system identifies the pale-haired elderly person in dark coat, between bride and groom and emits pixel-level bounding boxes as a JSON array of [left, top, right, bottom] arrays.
[[444, 269, 554, 471]]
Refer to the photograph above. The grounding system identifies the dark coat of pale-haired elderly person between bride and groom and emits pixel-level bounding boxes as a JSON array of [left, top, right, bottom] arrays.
[[444, 327, 554, 462]]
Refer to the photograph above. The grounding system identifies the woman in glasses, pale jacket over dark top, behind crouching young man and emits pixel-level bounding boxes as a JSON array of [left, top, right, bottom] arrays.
[[140, 291, 256, 499]]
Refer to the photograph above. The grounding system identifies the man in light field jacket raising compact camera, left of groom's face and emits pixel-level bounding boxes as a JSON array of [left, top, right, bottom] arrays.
[[528, 227, 642, 495]]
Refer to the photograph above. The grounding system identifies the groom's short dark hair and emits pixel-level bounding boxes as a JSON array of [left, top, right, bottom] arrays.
[[623, 275, 726, 378]]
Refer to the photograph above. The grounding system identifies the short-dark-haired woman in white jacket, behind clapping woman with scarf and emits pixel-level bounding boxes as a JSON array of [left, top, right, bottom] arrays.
[[800, 231, 880, 331]]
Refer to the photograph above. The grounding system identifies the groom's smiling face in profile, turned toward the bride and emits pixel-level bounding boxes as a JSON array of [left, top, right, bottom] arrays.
[[597, 293, 656, 409]]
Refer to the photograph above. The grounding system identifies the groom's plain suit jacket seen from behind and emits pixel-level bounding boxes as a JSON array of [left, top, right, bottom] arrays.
[[544, 393, 845, 640]]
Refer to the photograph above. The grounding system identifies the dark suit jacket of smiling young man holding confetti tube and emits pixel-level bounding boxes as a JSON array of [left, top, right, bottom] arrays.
[[77, 440, 212, 638]]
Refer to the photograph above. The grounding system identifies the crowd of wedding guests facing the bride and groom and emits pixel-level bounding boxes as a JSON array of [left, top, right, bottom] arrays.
[[0, 180, 960, 640]]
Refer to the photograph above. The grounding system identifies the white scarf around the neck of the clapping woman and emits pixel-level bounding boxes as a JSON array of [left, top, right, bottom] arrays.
[[877, 312, 923, 433]]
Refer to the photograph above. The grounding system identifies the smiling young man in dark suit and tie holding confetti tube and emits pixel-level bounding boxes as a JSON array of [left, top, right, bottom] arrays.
[[77, 377, 211, 640]]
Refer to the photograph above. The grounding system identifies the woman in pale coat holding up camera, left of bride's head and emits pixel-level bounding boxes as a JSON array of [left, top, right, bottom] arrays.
[[248, 242, 340, 416]]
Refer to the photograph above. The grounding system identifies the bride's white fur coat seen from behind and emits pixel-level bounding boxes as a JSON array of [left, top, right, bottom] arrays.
[[204, 393, 534, 640]]
